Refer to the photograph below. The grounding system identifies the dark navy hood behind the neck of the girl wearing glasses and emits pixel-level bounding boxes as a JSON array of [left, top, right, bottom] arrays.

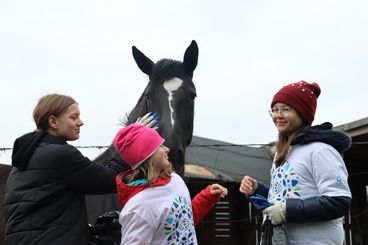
[[291, 122, 351, 154]]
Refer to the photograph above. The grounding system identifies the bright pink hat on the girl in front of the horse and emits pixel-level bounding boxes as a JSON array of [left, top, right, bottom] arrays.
[[114, 123, 165, 169]]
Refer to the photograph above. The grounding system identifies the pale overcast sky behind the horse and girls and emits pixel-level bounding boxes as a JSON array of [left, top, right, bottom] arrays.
[[0, 0, 368, 162]]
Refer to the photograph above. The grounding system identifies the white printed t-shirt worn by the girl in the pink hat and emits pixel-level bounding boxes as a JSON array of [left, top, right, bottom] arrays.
[[119, 173, 197, 245]]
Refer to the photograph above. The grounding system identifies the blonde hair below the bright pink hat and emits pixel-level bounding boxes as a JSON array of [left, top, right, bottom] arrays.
[[123, 155, 172, 184]]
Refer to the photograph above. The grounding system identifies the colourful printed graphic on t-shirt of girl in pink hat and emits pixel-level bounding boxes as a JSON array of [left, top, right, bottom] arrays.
[[164, 196, 196, 245]]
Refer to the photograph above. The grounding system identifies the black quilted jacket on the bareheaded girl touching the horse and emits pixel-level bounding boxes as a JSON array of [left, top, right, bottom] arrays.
[[4, 131, 126, 245]]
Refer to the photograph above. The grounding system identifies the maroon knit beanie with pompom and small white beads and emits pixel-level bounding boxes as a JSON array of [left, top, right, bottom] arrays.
[[271, 81, 321, 125]]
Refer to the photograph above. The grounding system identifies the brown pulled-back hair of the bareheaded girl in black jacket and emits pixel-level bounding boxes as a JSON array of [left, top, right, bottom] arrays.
[[33, 94, 77, 131]]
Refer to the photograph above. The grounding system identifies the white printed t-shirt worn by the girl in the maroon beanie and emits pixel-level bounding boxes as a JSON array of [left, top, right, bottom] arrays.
[[268, 142, 351, 245]]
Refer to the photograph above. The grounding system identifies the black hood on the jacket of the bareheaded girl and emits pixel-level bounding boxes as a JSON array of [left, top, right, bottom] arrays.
[[12, 130, 66, 171]]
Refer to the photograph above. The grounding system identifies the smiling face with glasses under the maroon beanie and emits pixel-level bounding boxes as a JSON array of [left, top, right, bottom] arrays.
[[271, 103, 304, 136]]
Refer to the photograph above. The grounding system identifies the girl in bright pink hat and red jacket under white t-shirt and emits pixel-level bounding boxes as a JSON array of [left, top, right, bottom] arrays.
[[114, 124, 227, 245]]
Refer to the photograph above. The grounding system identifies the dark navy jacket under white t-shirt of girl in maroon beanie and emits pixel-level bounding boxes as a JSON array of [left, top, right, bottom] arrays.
[[256, 123, 351, 223]]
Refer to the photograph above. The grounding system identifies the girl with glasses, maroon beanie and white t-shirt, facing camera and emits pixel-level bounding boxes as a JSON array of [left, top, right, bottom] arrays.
[[240, 81, 351, 244]]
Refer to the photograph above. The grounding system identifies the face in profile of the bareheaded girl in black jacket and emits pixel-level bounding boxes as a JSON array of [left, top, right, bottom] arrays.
[[49, 104, 83, 141]]
